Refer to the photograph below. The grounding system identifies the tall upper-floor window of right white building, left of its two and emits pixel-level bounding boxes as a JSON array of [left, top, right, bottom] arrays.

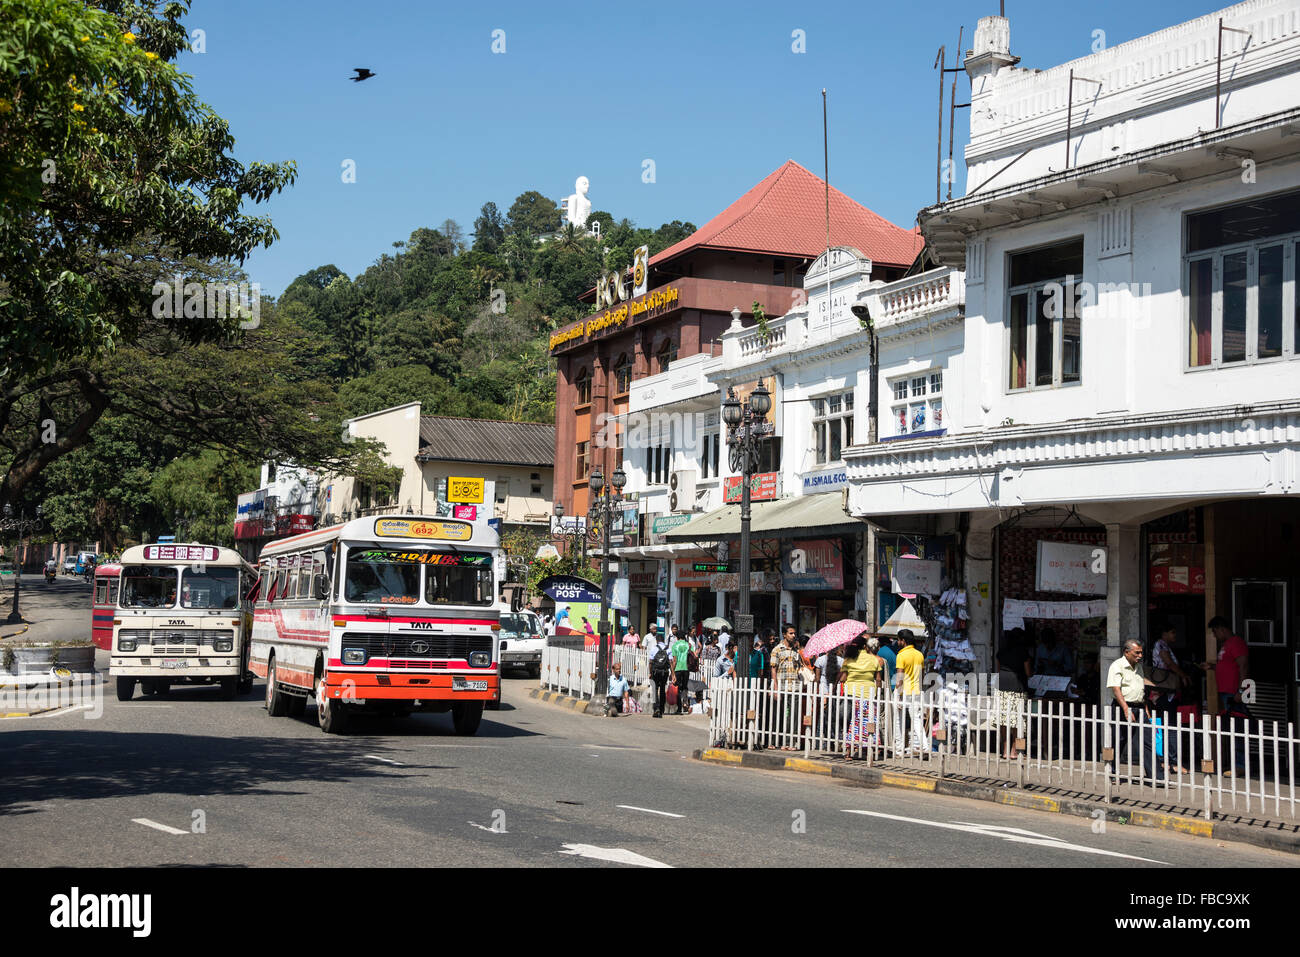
[[1006, 239, 1083, 391]]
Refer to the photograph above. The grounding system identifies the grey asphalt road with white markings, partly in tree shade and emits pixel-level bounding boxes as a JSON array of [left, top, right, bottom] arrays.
[[0, 677, 1300, 869]]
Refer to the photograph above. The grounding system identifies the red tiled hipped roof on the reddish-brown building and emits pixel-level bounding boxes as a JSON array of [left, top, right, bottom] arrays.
[[650, 160, 926, 265]]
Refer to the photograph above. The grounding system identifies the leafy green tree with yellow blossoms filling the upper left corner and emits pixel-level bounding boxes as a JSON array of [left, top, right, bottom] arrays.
[[0, 0, 295, 382]]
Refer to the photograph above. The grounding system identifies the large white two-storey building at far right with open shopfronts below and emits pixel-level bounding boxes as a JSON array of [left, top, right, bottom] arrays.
[[845, 0, 1300, 719]]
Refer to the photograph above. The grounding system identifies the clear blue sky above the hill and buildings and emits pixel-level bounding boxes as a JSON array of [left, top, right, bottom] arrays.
[[179, 0, 1222, 295]]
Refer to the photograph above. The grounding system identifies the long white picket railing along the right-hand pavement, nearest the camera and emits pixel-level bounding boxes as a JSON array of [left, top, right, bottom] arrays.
[[709, 676, 1300, 819]]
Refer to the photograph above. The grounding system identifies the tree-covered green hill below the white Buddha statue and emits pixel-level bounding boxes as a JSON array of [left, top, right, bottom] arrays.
[[278, 190, 696, 423]]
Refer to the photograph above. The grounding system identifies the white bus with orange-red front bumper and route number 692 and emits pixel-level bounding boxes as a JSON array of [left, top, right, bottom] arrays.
[[252, 516, 506, 735]]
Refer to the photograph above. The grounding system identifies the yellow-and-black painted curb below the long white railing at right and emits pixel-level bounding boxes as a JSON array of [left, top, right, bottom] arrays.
[[690, 748, 1300, 854]]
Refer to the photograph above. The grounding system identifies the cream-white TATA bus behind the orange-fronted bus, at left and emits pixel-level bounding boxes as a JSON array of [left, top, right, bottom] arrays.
[[108, 545, 257, 701]]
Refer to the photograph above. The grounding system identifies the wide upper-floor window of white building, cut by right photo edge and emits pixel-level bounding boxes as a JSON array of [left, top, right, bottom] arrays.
[[1183, 191, 1300, 369]]
